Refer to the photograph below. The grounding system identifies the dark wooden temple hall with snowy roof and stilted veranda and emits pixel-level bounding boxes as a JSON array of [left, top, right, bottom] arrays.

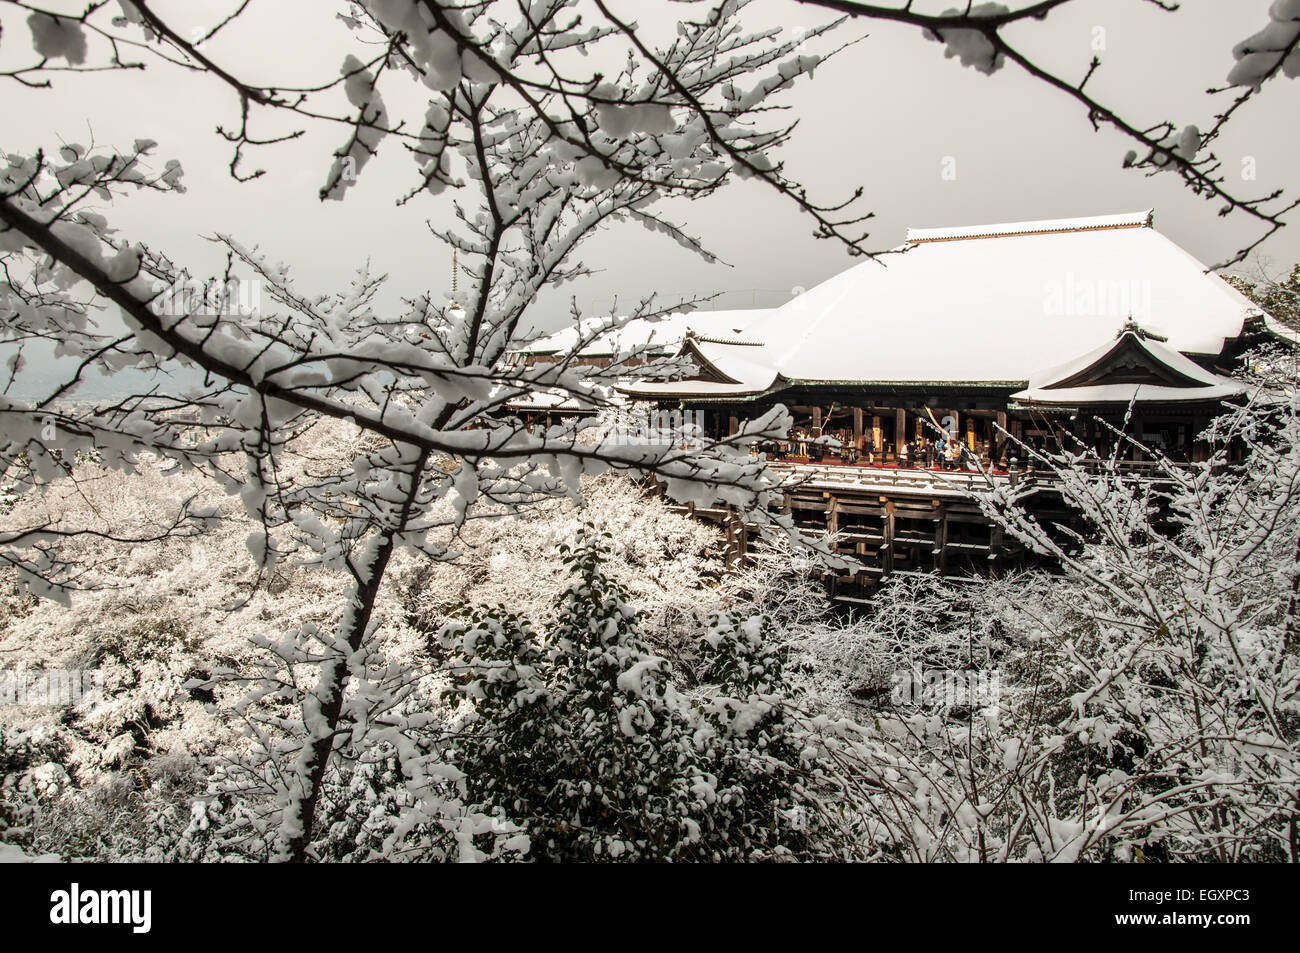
[[512, 211, 1295, 588]]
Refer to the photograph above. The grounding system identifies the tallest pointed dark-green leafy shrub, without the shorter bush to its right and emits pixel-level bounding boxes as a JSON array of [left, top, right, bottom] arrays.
[[439, 534, 714, 861]]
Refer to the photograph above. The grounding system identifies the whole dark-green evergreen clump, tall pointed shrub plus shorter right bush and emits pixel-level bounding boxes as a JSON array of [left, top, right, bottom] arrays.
[[439, 532, 837, 861]]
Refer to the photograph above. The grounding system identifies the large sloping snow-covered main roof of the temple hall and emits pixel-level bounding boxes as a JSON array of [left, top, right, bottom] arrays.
[[618, 211, 1261, 398]]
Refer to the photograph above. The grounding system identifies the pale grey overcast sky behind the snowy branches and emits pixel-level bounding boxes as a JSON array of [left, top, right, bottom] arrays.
[[0, 0, 1300, 343]]
